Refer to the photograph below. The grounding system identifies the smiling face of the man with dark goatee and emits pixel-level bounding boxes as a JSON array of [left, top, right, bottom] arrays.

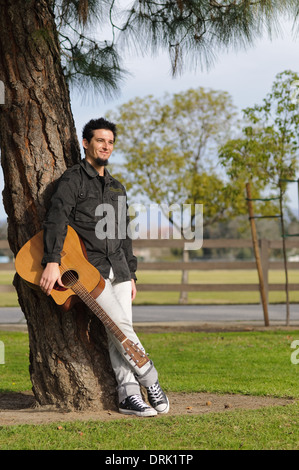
[[83, 129, 114, 167]]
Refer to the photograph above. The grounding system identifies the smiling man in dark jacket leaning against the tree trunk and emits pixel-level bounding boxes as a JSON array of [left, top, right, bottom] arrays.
[[40, 118, 169, 416]]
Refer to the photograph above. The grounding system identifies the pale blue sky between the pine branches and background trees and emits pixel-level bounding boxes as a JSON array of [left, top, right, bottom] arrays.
[[0, 18, 299, 220]]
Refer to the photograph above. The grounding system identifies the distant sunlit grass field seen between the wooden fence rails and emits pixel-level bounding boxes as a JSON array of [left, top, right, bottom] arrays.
[[0, 270, 299, 307]]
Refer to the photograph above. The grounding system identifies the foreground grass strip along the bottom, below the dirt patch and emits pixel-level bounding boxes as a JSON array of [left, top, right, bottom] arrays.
[[0, 405, 299, 450]]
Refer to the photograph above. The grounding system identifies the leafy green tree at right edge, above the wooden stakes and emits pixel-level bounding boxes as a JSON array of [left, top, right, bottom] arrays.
[[219, 71, 299, 215]]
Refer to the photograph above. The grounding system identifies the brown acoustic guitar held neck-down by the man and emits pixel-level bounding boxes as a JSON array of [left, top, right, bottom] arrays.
[[15, 226, 149, 368]]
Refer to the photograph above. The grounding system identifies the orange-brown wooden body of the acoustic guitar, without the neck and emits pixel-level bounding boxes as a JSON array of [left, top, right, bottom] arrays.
[[15, 226, 105, 311]]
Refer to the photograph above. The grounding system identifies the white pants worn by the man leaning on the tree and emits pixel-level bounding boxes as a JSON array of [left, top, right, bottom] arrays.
[[96, 273, 158, 402]]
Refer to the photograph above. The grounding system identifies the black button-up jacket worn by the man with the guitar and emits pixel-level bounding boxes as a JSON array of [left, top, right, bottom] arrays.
[[42, 160, 137, 282]]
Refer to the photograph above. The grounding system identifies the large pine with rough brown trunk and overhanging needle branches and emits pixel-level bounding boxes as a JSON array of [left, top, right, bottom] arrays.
[[0, 0, 293, 408]]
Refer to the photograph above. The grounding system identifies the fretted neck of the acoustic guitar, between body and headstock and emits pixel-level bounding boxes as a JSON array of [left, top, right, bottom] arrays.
[[72, 283, 127, 343]]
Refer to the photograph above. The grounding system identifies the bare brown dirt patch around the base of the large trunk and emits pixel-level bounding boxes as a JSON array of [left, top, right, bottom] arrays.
[[0, 392, 294, 426]]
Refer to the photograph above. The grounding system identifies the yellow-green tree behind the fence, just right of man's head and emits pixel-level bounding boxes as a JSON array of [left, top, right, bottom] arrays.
[[108, 88, 241, 303]]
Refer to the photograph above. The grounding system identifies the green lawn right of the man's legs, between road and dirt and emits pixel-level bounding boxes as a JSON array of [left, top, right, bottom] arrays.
[[139, 331, 299, 398]]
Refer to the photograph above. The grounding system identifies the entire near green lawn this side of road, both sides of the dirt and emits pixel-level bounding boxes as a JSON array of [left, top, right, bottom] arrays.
[[0, 331, 299, 450]]
